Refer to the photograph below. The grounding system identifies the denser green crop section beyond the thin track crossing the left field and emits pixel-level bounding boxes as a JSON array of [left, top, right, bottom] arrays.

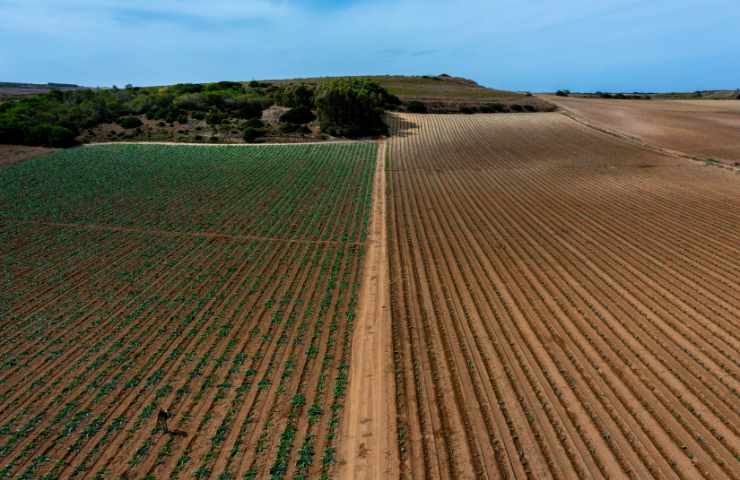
[[0, 143, 376, 240]]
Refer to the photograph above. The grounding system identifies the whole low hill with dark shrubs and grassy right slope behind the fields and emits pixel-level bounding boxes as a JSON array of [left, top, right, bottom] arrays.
[[0, 75, 555, 147]]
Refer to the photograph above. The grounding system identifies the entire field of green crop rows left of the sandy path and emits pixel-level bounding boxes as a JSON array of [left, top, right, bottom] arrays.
[[0, 143, 377, 479]]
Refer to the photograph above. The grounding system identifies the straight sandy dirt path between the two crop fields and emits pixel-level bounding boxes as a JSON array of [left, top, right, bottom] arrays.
[[338, 142, 399, 479]]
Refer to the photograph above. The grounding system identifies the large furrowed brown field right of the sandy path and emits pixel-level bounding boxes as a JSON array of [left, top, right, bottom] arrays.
[[387, 114, 740, 479]]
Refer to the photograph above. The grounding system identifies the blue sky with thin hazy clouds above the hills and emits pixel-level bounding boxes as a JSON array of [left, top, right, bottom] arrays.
[[0, 0, 740, 91]]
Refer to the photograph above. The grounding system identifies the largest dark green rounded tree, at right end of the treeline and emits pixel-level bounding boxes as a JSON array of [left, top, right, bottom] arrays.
[[316, 78, 390, 137]]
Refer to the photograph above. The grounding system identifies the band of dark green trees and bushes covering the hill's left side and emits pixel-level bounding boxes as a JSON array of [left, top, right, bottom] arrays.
[[0, 79, 401, 147]]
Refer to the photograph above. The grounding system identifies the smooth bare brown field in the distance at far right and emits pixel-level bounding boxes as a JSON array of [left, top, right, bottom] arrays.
[[543, 96, 740, 164]]
